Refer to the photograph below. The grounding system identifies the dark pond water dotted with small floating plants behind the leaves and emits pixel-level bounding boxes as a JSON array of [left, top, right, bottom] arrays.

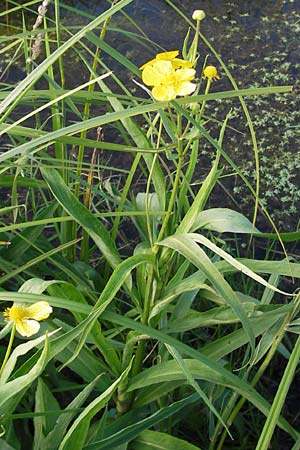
[[1, 0, 300, 231]]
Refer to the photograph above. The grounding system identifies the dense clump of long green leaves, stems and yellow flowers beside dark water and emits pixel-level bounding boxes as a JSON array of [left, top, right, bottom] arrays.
[[0, 0, 300, 450]]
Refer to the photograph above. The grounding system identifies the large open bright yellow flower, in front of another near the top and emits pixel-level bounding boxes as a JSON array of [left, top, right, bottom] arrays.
[[142, 60, 196, 101]]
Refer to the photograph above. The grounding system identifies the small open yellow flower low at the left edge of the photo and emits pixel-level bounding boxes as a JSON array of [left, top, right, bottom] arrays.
[[3, 302, 52, 337]]
